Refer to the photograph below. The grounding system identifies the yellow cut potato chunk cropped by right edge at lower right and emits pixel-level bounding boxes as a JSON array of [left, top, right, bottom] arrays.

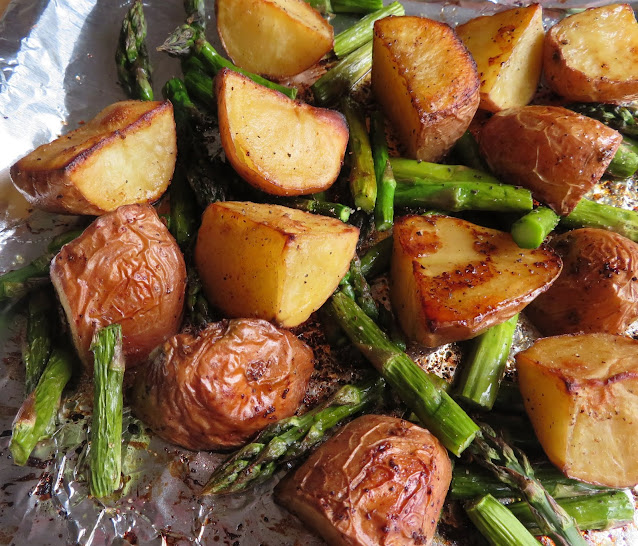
[[516, 334, 638, 487]]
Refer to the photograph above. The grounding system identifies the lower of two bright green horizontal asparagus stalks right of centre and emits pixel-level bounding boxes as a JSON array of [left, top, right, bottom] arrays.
[[394, 180, 534, 212]]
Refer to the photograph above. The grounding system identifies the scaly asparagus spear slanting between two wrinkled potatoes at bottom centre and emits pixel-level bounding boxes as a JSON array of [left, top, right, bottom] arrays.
[[202, 376, 385, 495]]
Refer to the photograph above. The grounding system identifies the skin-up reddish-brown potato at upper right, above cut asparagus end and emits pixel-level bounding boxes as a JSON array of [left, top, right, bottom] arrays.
[[479, 106, 622, 215]]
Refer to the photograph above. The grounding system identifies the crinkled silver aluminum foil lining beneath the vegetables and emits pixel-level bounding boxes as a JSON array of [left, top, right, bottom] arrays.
[[0, 0, 638, 546]]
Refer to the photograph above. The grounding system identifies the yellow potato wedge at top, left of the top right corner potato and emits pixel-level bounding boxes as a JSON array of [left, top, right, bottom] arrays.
[[455, 4, 545, 112]]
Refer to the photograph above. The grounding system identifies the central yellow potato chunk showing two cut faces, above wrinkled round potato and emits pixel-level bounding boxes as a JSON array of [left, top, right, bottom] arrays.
[[195, 201, 359, 327]]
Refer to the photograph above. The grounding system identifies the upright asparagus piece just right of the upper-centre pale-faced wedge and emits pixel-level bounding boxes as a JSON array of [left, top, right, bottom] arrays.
[[341, 98, 377, 213]]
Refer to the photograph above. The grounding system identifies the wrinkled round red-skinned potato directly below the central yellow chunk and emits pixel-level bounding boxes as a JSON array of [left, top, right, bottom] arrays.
[[134, 319, 313, 450]]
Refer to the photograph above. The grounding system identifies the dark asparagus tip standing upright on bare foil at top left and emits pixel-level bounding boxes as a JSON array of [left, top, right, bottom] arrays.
[[115, 0, 153, 100]]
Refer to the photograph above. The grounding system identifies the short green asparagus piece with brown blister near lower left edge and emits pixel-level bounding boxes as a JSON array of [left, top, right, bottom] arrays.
[[9, 348, 73, 466]]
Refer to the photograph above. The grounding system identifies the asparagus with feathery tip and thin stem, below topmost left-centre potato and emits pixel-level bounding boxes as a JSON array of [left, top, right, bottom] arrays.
[[157, 23, 297, 99]]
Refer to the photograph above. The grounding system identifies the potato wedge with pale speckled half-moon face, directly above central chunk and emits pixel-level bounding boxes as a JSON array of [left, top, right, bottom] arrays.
[[216, 69, 348, 195]]
